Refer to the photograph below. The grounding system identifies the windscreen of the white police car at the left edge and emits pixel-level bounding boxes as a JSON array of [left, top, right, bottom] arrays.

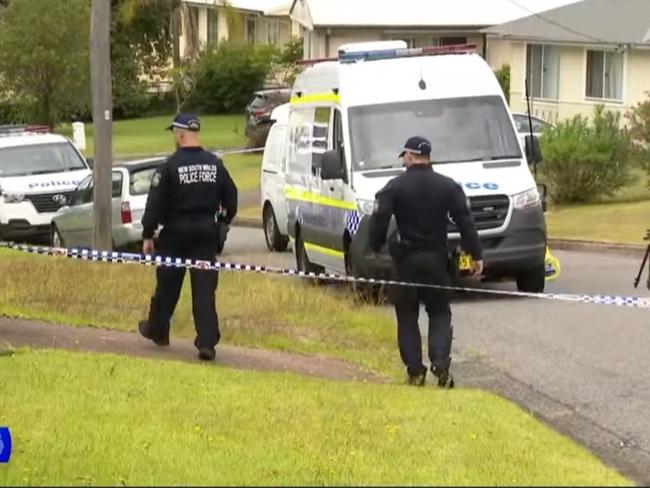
[[0, 142, 86, 176]]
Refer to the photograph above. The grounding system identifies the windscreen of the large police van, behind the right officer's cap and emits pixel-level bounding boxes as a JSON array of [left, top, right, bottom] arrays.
[[349, 96, 522, 171]]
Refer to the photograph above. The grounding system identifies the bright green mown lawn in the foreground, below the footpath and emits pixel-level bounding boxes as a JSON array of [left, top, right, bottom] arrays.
[[0, 351, 631, 486]]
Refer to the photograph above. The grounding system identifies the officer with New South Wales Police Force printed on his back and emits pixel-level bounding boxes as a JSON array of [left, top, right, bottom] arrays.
[[138, 114, 237, 361]]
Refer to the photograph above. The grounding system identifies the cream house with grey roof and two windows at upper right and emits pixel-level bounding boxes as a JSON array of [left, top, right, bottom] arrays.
[[483, 0, 650, 122]]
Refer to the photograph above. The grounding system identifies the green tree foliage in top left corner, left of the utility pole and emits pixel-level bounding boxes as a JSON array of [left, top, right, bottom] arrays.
[[0, 0, 90, 126]]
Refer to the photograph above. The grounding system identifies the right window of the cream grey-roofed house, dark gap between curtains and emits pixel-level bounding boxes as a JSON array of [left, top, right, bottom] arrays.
[[586, 50, 623, 100]]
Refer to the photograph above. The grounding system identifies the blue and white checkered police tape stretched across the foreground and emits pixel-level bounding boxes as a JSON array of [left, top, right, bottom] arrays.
[[0, 242, 650, 309]]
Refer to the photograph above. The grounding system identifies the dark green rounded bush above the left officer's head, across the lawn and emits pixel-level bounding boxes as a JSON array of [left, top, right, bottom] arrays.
[[188, 43, 275, 114]]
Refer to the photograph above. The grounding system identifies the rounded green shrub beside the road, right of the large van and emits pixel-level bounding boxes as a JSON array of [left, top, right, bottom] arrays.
[[540, 106, 635, 204]]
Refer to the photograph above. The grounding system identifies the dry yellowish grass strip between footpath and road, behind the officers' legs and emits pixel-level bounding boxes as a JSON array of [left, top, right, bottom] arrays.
[[0, 251, 403, 380]]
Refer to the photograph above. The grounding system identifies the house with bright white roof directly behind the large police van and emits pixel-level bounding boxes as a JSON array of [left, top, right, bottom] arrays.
[[290, 0, 577, 59]]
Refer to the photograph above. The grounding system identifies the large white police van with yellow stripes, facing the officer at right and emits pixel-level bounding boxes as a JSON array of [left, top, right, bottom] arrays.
[[285, 41, 547, 292]]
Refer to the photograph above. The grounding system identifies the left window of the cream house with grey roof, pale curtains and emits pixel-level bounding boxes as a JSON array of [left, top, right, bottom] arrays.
[[526, 44, 560, 100]]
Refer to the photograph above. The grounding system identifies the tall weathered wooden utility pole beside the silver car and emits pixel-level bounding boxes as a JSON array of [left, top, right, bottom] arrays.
[[90, 0, 113, 251]]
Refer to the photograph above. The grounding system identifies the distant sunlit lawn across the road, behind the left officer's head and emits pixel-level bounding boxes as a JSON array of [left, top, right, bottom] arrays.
[[57, 115, 246, 159]]
